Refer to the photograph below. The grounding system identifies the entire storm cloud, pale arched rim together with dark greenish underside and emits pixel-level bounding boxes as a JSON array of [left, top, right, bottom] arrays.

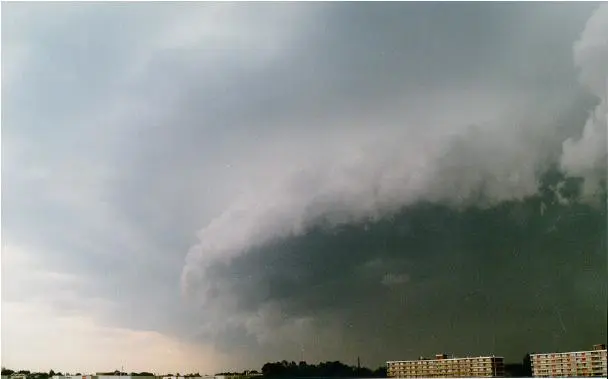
[[182, 0, 608, 368]]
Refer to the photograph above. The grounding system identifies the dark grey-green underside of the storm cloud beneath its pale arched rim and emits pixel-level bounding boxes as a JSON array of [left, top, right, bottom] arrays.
[[208, 170, 607, 364]]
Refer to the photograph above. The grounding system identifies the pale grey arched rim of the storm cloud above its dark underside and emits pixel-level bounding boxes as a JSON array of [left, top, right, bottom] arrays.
[[183, 3, 604, 362]]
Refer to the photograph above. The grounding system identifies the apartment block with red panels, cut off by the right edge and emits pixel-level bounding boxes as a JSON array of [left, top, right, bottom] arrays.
[[530, 344, 608, 377]]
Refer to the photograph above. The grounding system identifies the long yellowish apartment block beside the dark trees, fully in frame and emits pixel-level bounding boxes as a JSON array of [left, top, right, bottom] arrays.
[[386, 354, 504, 378]]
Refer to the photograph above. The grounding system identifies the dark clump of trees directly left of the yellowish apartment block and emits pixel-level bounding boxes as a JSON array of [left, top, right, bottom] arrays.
[[262, 361, 386, 378]]
